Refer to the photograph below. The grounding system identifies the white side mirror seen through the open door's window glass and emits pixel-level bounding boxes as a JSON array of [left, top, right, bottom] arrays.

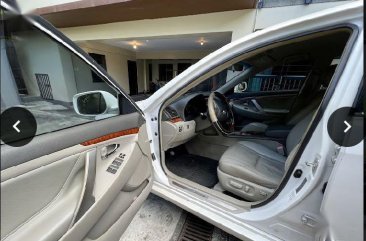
[[72, 90, 119, 117]]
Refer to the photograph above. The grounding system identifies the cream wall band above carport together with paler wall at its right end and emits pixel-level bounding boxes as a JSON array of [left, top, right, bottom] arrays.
[[61, 0, 354, 41]]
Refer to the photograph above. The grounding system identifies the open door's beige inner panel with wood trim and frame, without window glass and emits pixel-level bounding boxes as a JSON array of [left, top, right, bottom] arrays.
[[1, 1, 152, 241]]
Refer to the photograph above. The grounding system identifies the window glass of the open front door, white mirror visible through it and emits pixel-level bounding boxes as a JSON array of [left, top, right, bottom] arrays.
[[1, 12, 136, 141]]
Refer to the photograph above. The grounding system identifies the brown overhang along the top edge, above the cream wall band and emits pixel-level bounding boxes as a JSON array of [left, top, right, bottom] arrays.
[[36, 0, 257, 28]]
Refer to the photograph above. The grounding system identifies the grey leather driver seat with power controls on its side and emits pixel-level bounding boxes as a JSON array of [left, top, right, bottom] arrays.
[[217, 111, 314, 201]]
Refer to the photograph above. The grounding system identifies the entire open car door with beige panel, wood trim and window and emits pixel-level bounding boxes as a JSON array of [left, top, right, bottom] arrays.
[[0, 1, 152, 241]]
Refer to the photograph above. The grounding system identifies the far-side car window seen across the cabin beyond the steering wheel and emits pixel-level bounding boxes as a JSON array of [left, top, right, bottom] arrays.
[[234, 61, 311, 93]]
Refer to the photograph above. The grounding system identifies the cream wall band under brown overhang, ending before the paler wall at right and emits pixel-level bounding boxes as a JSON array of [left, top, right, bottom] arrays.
[[61, 9, 256, 41]]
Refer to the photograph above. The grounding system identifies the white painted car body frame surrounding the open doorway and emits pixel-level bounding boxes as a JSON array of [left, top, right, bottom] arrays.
[[138, 1, 363, 240]]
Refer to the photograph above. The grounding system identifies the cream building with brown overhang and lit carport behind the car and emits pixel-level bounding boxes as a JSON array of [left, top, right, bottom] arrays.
[[2, 0, 350, 104]]
